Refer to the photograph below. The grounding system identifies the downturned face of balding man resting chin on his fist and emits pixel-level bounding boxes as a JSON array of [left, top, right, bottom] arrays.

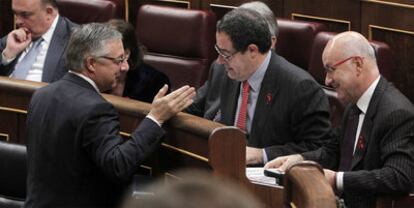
[[12, 0, 57, 38]]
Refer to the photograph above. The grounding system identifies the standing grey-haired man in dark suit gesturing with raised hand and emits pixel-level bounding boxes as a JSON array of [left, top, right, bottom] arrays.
[[25, 23, 195, 208]]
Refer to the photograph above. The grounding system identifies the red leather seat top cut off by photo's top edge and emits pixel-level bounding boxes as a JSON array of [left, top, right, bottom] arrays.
[[57, 0, 116, 24]]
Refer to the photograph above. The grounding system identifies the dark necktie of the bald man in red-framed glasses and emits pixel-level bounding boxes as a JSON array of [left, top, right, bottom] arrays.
[[339, 105, 361, 171]]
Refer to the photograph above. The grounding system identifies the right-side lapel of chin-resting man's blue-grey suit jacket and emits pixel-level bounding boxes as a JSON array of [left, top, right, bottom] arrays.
[[42, 17, 69, 82]]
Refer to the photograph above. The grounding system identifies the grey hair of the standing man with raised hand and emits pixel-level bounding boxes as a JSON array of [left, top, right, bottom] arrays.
[[66, 23, 122, 72]]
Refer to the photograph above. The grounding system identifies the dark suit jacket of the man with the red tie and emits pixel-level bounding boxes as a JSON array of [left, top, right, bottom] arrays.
[[186, 53, 330, 160]]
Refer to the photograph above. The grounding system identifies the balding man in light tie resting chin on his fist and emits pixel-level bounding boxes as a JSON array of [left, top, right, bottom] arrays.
[[0, 0, 76, 82]]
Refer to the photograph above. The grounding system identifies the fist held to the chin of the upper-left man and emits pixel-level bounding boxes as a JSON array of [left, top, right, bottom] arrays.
[[3, 28, 32, 59]]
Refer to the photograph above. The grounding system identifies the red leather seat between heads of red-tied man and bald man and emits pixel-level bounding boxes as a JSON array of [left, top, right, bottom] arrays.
[[276, 18, 326, 70]]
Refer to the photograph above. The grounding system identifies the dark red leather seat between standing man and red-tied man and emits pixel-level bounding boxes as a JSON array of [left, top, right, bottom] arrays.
[[136, 5, 217, 89]]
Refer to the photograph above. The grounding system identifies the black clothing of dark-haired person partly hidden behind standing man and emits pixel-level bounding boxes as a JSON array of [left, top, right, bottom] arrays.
[[123, 63, 170, 103]]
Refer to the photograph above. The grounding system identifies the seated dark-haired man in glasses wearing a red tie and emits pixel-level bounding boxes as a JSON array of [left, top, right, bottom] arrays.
[[186, 8, 330, 164]]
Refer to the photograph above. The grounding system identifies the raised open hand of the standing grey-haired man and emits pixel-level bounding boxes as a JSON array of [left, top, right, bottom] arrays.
[[149, 85, 196, 123]]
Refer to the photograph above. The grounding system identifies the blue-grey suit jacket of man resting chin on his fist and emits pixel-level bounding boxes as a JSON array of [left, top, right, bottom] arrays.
[[0, 16, 77, 82]]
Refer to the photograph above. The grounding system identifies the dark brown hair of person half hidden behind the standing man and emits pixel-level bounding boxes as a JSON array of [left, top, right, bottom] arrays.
[[108, 19, 145, 70]]
